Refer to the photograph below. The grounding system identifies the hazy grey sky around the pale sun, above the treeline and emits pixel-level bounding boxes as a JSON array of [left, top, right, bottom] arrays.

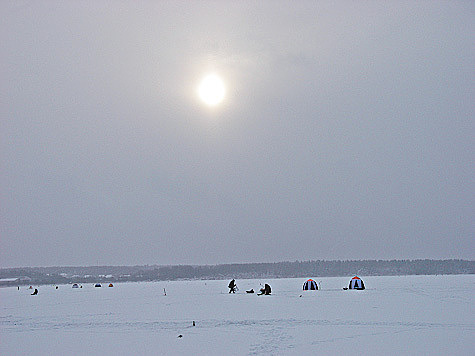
[[0, 0, 475, 267]]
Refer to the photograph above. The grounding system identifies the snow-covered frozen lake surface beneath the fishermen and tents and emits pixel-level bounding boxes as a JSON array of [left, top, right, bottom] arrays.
[[0, 275, 475, 356]]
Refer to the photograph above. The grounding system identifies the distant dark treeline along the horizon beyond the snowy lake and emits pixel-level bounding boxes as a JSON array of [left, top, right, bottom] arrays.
[[0, 260, 475, 286]]
